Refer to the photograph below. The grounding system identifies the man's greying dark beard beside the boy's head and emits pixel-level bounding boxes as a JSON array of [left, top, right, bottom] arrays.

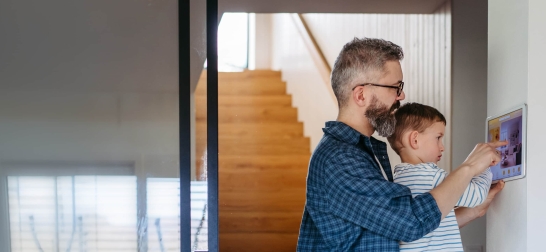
[[364, 95, 400, 137]]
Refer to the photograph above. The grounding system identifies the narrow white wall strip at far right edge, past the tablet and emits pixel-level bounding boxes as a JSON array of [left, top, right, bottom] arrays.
[[527, 0, 546, 251]]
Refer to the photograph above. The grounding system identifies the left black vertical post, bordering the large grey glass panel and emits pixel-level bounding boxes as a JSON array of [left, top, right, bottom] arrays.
[[178, 0, 192, 252]]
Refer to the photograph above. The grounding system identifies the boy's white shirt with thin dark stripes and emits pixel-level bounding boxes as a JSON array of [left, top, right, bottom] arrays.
[[394, 163, 493, 251]]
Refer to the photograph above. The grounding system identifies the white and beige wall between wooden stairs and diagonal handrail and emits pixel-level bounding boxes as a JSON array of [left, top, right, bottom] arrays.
[[271, 14, 337, 151]]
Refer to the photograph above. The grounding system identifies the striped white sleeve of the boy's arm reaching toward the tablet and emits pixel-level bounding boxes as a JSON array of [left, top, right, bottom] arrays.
[[434, 165, 493, 207]]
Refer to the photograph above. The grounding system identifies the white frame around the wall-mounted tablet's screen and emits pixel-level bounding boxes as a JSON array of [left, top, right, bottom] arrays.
[[485, 103, 527, 183]]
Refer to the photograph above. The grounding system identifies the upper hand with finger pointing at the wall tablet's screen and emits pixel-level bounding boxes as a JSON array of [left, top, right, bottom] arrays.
[[462, 141, 508, 176]]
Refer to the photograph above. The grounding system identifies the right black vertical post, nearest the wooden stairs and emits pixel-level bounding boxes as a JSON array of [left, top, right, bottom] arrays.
[[207, 0, 219, 252]]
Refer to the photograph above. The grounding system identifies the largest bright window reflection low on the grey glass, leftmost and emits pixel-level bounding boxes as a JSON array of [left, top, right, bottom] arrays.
[[8, 176, 137, 252]]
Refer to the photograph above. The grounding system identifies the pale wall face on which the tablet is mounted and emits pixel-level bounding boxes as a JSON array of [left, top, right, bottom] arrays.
[[487, 0, 528, 251]]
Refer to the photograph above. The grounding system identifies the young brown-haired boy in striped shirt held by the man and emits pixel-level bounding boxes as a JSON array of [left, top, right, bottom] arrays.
[[388, 103, 492, 251]]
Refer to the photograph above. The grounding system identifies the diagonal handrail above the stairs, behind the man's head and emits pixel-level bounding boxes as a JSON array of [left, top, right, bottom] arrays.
[[291, 13, 337, 104]]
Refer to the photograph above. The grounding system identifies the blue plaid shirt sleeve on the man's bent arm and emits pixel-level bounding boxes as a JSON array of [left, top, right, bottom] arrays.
[[324, 152, 442, 242]]
